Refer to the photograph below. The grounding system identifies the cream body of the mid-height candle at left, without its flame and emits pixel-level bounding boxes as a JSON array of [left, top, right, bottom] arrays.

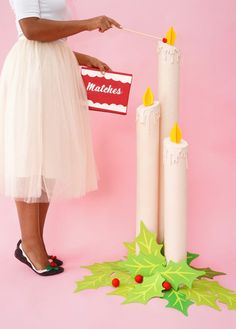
[[136, 101, 160, 242]]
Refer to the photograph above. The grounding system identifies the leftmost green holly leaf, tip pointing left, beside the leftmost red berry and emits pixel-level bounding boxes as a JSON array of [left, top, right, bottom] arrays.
[[74, 273, 111, 292]]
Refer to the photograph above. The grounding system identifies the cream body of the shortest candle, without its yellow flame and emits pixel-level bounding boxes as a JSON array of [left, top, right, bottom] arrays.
[[163, 138, 188, 262]]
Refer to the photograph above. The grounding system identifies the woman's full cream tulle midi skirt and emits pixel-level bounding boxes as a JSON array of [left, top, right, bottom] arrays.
[[0, 36, 100, 203]]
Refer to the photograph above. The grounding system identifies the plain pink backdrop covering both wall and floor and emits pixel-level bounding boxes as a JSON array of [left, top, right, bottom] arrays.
[[0, 0, 236, 329]]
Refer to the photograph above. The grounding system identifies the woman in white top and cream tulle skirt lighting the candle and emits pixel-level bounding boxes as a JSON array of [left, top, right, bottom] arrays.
[[0, 0, 120, 276]]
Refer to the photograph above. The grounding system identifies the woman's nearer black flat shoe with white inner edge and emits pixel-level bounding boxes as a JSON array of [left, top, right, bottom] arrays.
[[15, 241, 64, 276]]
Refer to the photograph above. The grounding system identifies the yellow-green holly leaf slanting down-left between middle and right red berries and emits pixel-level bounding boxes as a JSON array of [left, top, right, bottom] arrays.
[[122, 272, 165, 304]]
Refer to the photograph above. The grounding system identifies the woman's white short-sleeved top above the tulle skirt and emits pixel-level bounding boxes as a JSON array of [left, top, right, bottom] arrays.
[[9, 0, 71, 36]]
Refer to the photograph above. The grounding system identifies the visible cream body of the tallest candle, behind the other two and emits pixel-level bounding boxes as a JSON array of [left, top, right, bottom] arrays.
[[157, 41, 180, 243]]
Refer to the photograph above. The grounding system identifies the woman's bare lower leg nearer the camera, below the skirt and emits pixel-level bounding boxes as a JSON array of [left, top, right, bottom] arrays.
[[15, 200, 50, 270]]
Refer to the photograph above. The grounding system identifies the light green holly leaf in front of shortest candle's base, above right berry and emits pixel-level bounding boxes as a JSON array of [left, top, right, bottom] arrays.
[[160, 260, 205, 290]]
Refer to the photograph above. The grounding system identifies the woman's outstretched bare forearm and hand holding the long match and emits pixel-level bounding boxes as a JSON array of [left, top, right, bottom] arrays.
[[19, 16, 121, 41]]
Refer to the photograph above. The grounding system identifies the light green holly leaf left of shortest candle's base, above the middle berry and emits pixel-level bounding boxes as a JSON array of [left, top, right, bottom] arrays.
[[121, 254, 164, 277]]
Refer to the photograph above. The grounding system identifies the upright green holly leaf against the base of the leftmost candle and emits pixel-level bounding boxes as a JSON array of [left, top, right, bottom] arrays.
[[136, 221, 165, 260]]
